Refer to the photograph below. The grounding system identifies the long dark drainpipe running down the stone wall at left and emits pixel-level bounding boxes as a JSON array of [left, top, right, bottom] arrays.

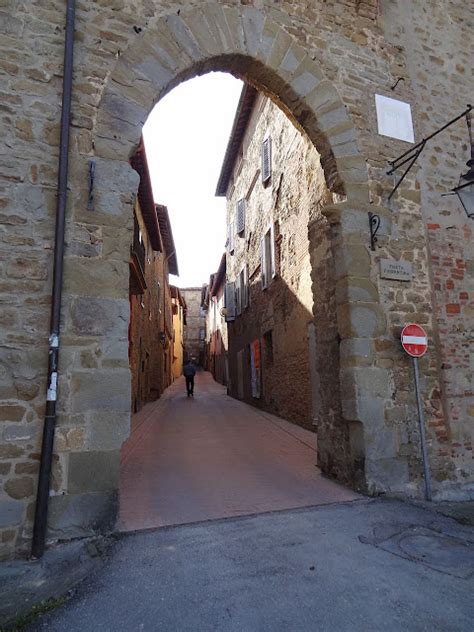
[[31, 0, 75, 558]]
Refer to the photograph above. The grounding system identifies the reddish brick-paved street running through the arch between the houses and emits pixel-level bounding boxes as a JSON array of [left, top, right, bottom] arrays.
[[120, 372, 359, 531]]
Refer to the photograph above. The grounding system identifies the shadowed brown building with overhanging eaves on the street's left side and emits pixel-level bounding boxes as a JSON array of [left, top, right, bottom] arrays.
[[129, 141, 178, 413]]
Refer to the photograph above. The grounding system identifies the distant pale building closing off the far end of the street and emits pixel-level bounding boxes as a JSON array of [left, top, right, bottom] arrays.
[[181, 287, 206, 366]]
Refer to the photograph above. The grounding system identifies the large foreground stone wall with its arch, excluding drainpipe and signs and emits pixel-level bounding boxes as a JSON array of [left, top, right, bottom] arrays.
[[0, 0, 474, 556]]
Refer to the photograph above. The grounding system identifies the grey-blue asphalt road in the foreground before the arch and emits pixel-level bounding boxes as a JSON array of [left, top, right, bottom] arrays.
[[33, 499, 474, 632]]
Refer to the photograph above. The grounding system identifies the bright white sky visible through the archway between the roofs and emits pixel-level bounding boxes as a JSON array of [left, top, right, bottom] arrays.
[[143, 72, 242, 287]]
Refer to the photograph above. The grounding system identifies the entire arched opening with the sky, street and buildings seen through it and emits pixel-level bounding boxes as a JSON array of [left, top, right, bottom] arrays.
[[120, 73, 360, 531]]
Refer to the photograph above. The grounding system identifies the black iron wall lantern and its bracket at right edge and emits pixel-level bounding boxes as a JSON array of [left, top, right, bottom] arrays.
[[387, 105, 474, 219]]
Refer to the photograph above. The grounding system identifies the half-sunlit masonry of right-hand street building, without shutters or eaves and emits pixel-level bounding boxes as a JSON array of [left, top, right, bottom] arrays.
[[227, 95, 330, 430]]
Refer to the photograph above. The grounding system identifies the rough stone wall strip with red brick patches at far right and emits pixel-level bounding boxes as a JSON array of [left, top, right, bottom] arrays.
[[382, 0, 474, 498]]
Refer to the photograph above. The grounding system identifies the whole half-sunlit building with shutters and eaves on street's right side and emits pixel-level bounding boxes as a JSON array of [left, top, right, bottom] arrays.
[[218, 85, 330, 430]]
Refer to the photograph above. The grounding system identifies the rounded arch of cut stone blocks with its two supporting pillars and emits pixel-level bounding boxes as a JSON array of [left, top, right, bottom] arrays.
[[51, 3, 388, 536]]
